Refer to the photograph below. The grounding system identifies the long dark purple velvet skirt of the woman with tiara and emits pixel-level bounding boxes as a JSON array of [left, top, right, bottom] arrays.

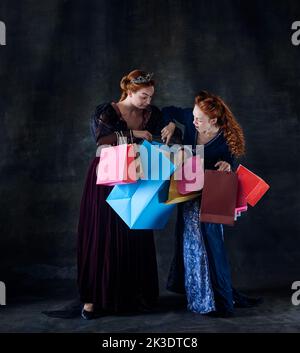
[[77, 157, 158, 312]]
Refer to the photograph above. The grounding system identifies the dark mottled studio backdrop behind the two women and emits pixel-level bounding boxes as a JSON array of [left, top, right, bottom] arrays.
[[0, 0, 300, 296]]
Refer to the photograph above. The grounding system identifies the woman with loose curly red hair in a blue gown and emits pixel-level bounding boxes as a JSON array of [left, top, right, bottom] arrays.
[[162, 91, 255, 317]]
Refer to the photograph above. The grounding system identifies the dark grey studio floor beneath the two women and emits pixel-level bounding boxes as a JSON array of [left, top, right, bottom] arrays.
[[0, 288, 300, 333]]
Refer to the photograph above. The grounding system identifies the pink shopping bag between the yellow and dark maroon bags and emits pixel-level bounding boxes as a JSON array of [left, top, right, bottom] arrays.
[[174, 155, 204, 195]]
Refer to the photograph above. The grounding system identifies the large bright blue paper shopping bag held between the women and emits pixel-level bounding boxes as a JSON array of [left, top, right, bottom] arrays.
[[106, 141, 175, 229]]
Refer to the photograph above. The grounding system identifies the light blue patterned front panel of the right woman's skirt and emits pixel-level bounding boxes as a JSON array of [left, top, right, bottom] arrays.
[[183, 199, 215, 314]]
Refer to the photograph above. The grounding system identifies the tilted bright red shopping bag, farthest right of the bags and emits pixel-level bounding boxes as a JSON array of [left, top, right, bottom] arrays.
[[236, 164, 270, 206]]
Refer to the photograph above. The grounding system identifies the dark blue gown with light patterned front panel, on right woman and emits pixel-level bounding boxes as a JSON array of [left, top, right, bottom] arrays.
[[162, 106, 237, 313]]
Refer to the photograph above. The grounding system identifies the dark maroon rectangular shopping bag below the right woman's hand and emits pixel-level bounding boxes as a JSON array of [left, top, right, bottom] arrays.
[[200, 170, 238, 225]]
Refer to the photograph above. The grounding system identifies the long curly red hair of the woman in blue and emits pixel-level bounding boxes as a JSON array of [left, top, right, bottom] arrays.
[[195, 91, 245, 157]]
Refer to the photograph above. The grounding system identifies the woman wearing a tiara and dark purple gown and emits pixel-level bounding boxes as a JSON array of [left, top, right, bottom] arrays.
[[78, 70, 178, 319]]
